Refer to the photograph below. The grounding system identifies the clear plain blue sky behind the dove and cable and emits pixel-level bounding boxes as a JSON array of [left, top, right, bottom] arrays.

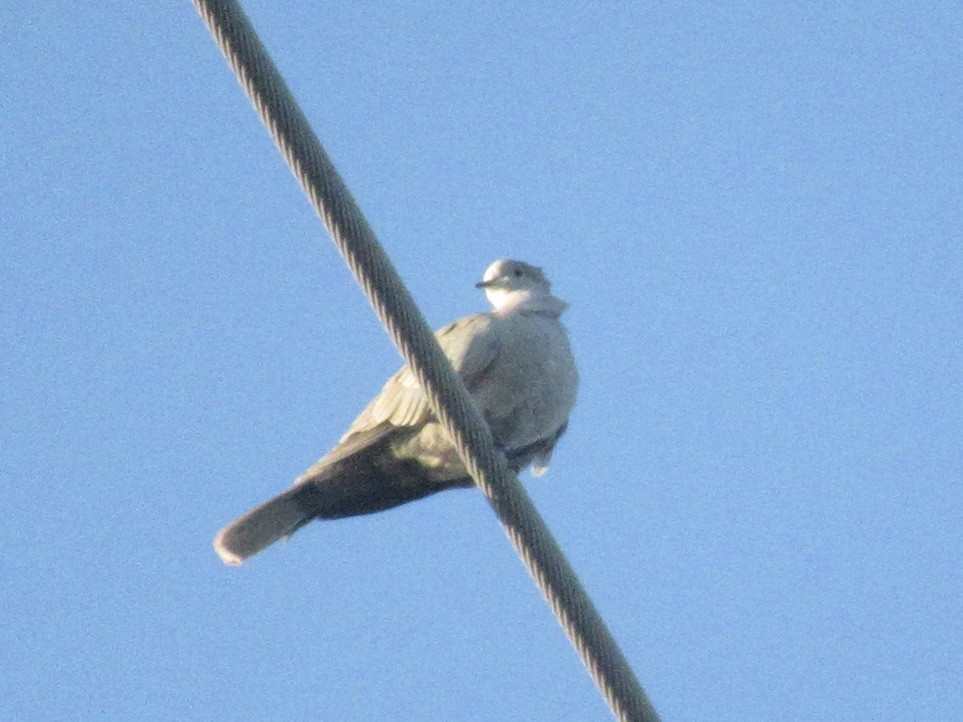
[[0, 0, 963, 721]]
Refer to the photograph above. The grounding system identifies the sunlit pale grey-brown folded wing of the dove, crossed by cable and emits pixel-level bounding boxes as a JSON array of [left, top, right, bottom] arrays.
[[339, 313, 503, 446]]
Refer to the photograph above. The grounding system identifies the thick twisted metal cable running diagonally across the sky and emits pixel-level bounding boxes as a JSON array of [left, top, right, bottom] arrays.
[[192, 0, 658, 722]]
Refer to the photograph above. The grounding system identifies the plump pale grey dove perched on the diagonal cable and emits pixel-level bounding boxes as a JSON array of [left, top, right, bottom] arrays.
[[214, 259, 579, 565]]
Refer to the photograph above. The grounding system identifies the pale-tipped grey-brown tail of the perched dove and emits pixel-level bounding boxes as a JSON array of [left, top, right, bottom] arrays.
[[214, 485, 314, 565]]
